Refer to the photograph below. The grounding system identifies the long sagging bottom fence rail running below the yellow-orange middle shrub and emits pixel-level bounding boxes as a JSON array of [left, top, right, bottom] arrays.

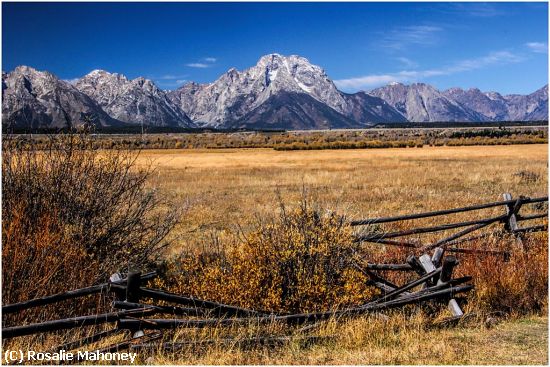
[[119, 285, 473, 330]]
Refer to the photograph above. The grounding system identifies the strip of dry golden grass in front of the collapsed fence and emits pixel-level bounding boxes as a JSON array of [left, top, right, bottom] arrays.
[[140, 313, 548, 365]]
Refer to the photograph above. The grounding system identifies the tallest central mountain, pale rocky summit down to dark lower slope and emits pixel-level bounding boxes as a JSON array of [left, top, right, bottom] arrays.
[[169, 54, 404, 128]]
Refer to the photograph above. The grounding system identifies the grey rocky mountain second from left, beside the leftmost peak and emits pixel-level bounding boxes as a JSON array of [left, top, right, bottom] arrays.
[[75, 70, 193, 127]]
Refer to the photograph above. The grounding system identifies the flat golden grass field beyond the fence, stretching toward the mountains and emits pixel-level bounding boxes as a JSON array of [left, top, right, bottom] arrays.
[[138, 145, 548, 251]]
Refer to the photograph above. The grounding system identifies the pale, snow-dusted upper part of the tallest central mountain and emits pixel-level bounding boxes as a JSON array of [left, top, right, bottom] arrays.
[[166, 53, 350, 126]]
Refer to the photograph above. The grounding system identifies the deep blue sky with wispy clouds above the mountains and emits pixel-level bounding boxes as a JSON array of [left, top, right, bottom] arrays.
[[2, 2, 548, 94]]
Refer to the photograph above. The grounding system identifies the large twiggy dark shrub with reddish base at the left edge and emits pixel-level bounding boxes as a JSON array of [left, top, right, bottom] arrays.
[[2, 135, 177, 322]]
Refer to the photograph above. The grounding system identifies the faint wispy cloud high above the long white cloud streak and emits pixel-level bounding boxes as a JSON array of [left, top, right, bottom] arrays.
[[380, 25, 443, 50]]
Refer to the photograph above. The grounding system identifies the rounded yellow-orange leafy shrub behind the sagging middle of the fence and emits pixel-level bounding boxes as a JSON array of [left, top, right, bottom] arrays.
[[157, 200, 377, 312]]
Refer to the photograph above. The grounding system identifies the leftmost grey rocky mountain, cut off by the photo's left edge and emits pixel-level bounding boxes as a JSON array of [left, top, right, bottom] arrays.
[[2, 66, 122, 129]]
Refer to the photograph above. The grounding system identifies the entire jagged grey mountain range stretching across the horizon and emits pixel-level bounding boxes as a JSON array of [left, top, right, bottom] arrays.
[[2, 54, 548, 129]]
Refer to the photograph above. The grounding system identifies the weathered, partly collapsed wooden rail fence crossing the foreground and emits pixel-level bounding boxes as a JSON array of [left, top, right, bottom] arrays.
[[2, 194, 548, 360]]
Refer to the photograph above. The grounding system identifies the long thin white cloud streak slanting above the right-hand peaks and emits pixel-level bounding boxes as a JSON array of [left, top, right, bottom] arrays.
[[334, 51, 524, 90]]
